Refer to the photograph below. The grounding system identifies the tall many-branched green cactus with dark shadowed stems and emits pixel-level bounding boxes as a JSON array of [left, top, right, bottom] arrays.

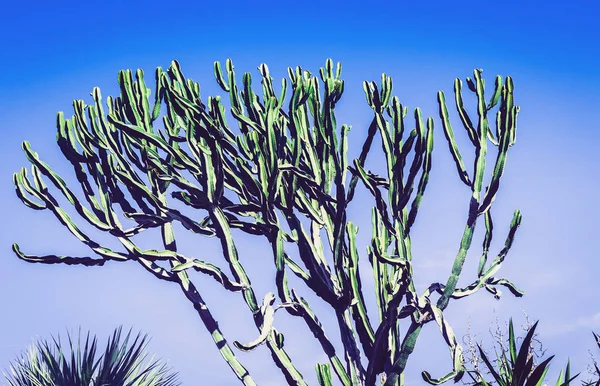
[[13, 60, 522, 386]]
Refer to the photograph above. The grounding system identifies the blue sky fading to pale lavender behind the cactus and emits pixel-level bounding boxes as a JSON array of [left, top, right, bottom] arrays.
[[0, 0, 600, 385]]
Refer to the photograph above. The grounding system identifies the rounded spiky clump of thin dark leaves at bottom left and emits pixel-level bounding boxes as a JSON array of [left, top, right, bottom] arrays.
[[5, 327, 179, 386]]
